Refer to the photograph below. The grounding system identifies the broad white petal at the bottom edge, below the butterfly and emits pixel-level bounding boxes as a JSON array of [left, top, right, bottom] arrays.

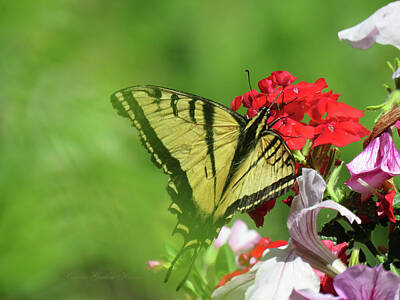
[[245, 243, 320, 300]]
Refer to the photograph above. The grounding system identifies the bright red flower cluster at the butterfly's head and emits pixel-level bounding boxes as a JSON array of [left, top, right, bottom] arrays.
[[231, 71, 368, 150]]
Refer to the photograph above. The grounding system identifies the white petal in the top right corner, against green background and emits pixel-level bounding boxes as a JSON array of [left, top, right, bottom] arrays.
[[338, 1, 400, 49]]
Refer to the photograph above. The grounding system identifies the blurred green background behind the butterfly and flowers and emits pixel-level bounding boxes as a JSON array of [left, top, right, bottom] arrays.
[[0, 0, 398, 299]]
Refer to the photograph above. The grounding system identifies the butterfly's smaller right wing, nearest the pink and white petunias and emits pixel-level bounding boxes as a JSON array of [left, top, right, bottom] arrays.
[[215, 130, 296, 217]]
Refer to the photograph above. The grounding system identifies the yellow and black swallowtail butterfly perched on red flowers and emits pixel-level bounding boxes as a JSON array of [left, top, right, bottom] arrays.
[[111, 85, 296, 290]]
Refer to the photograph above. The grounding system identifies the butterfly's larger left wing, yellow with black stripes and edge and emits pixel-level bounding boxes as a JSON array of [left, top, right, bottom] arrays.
[[111, 86, 247, 264]]
